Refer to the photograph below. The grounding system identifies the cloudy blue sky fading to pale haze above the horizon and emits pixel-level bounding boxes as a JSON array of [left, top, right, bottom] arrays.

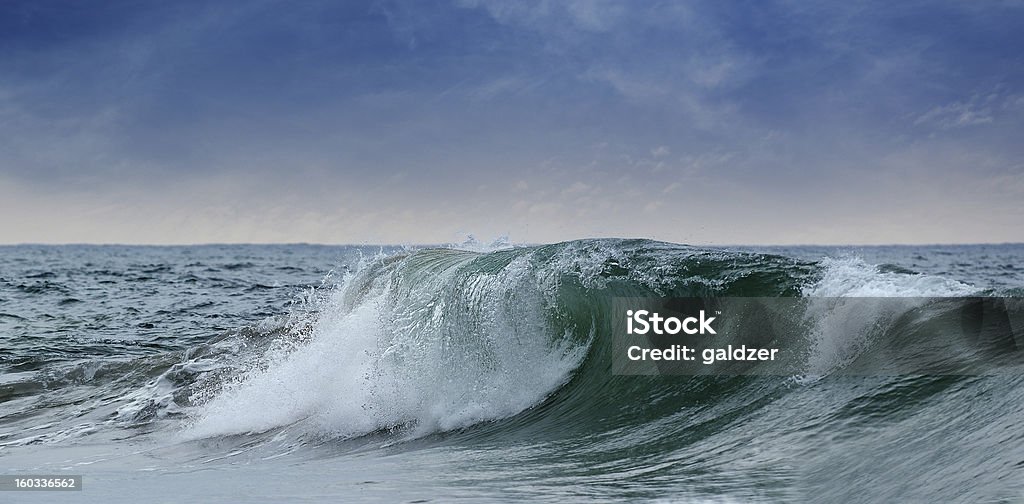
[[0, 0, 1024, 245]]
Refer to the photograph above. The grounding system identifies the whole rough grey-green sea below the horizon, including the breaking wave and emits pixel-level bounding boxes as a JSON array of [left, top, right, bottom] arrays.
[[0, 240, 1024, 502]]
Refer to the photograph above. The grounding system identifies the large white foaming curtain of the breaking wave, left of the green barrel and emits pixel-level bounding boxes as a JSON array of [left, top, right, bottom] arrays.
[[185, 247, 586, 437]]
